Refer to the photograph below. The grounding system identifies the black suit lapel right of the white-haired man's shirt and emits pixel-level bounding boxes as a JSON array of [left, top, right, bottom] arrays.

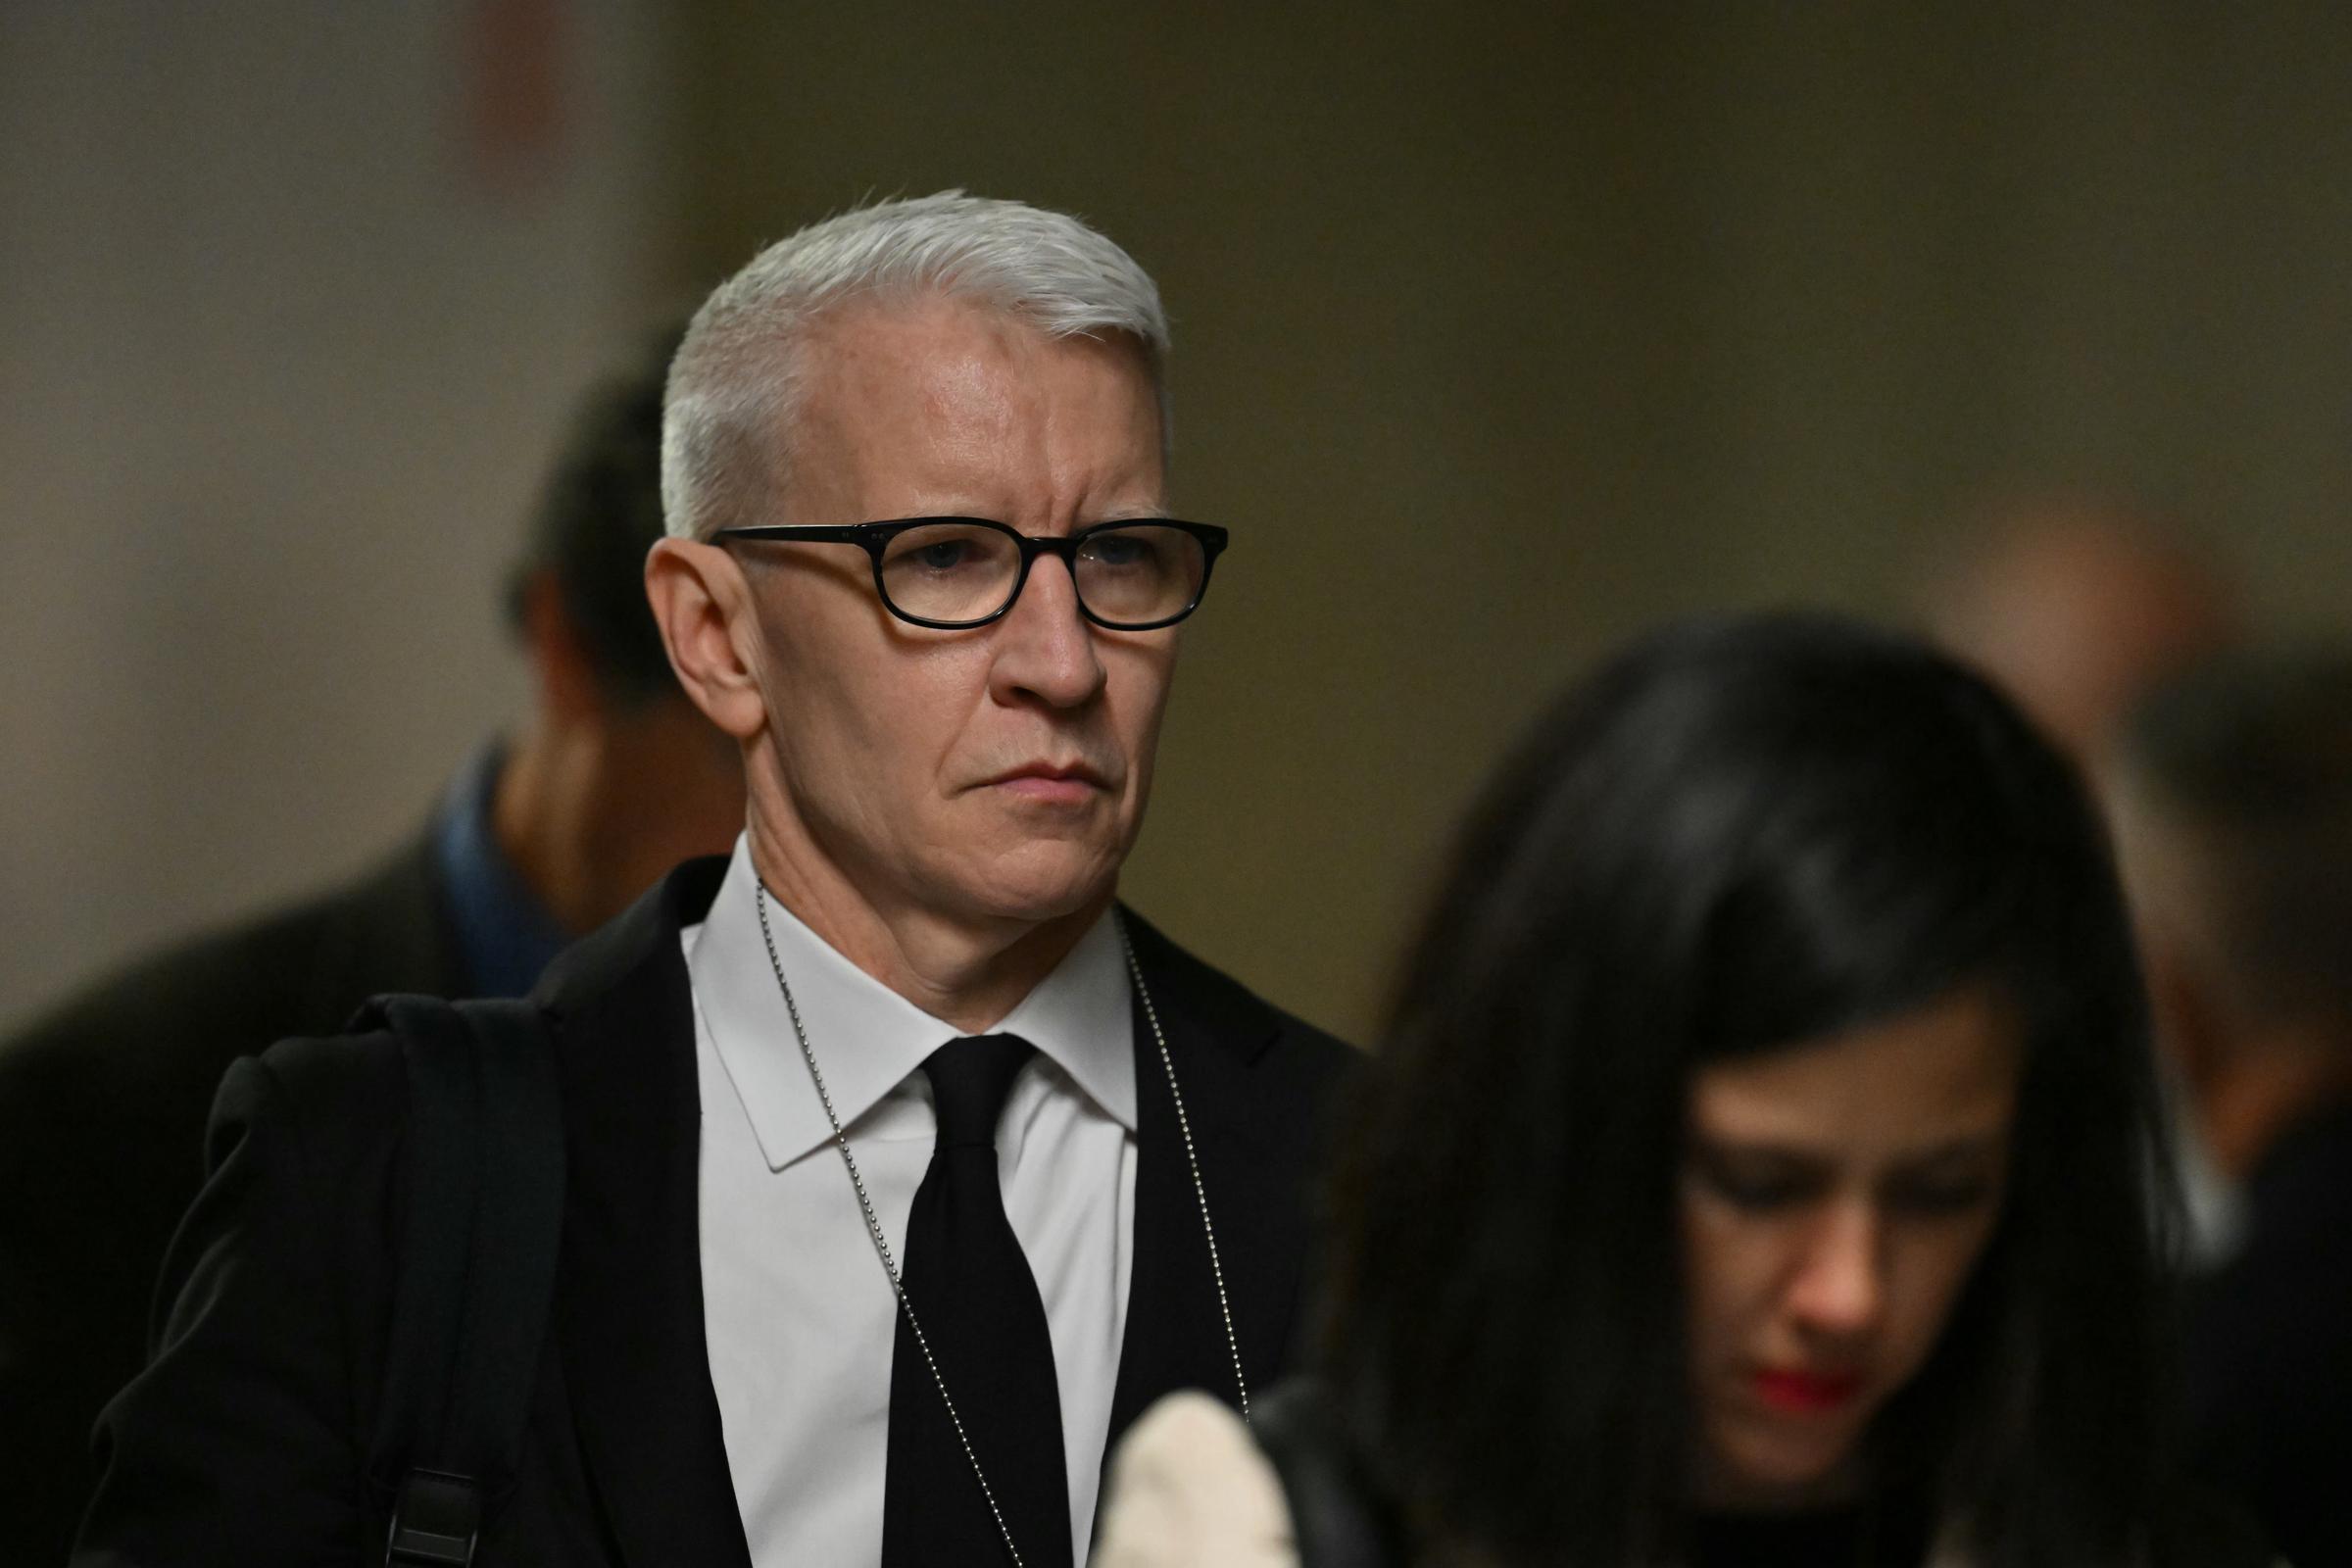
[[1103, 909, 1298, 1464]]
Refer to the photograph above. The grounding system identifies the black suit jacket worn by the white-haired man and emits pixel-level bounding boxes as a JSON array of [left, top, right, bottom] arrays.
[[75, 860, 1352, 1568]]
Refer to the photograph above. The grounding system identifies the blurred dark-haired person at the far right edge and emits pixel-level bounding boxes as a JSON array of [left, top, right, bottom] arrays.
[[2110, 647, 2352, 1563]]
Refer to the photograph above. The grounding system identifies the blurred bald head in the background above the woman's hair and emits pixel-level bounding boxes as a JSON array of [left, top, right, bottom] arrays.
[[1924, 494, 2239, 768]]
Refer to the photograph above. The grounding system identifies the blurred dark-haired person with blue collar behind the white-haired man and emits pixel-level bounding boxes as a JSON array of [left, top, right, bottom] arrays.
[[0, 326, 743, 1563]]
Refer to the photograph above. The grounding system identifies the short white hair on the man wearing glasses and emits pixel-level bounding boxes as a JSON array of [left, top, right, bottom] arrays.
[[661, 190, 1169, 538]]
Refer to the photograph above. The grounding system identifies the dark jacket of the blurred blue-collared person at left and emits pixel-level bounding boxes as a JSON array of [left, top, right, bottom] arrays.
[[0, 837, 466, 1563]]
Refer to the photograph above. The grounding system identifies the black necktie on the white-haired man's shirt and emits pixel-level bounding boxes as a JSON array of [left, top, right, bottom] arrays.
[[882, 1034, 1070, 1568]]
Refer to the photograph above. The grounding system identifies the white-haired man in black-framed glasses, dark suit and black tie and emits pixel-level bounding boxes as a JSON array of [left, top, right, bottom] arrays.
[[82, 193, 1350, 1568]]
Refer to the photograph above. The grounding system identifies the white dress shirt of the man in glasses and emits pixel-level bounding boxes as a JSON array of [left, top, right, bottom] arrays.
[[682, 839, 1136, 1568]]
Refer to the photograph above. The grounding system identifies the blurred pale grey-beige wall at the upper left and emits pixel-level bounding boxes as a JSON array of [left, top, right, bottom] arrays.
[[0, 0, 677, 1044]]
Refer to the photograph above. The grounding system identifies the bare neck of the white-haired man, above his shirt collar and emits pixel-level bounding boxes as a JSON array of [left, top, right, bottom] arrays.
[[751, 808, 1112, 1034]]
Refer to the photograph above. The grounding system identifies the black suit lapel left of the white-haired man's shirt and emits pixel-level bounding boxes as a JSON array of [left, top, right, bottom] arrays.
[[539, 860, 751, 1568]]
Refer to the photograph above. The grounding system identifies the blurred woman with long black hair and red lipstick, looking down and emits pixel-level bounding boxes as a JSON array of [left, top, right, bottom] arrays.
[[1096, 615, 2260, 1568]]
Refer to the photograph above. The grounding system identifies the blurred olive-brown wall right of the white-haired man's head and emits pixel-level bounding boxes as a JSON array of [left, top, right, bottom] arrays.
[[675, 0, 2352, 1034]]
